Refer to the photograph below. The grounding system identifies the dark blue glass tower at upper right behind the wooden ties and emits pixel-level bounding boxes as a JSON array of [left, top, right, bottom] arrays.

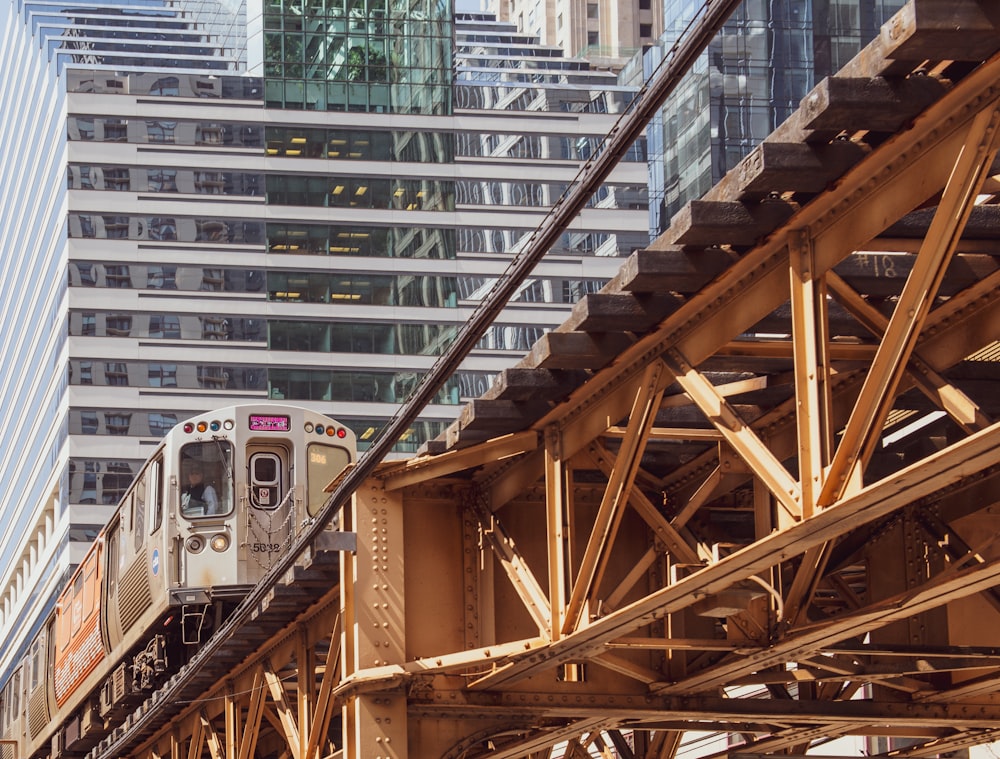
[[644, 0, 903, 235]]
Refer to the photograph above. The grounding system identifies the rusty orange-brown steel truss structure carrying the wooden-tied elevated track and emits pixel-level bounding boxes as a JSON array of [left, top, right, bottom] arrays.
[[80, 0, 1000, 759]]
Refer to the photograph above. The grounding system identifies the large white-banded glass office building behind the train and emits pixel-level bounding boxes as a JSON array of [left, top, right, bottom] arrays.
[[0, 0, 648, 680]]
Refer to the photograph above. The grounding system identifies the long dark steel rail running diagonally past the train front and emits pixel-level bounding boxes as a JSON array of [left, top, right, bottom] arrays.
[[94, 0, 741, 759]]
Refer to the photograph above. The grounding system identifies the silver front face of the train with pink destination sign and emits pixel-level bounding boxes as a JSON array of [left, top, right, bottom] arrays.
[[167, 404, 356, 606]]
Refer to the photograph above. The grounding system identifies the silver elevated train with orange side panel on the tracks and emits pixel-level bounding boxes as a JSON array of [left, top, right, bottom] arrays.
[[0, 404, 357, 759]]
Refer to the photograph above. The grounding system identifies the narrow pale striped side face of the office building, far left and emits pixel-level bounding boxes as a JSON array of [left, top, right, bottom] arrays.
[[0, 3, 69, 681]]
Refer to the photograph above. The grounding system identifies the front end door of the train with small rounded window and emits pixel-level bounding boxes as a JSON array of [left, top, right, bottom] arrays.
[[245, 443, 292, 583]]
